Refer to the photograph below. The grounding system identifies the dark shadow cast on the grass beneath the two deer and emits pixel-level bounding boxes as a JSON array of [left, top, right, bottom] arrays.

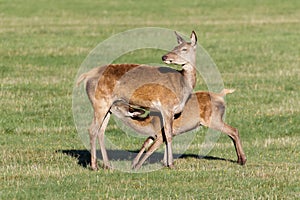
[[56, 149, 236, 168]]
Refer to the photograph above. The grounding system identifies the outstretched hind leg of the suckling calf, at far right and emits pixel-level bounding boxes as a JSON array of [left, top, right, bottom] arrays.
[[210, 119, 247, 165]]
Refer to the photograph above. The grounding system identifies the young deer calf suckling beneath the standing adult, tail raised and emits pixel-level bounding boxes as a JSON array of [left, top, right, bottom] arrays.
[[111, 89, 246, 168]]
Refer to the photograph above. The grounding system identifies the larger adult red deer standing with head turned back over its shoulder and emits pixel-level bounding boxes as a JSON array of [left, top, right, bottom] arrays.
[[77, 31, 197, 170]]
